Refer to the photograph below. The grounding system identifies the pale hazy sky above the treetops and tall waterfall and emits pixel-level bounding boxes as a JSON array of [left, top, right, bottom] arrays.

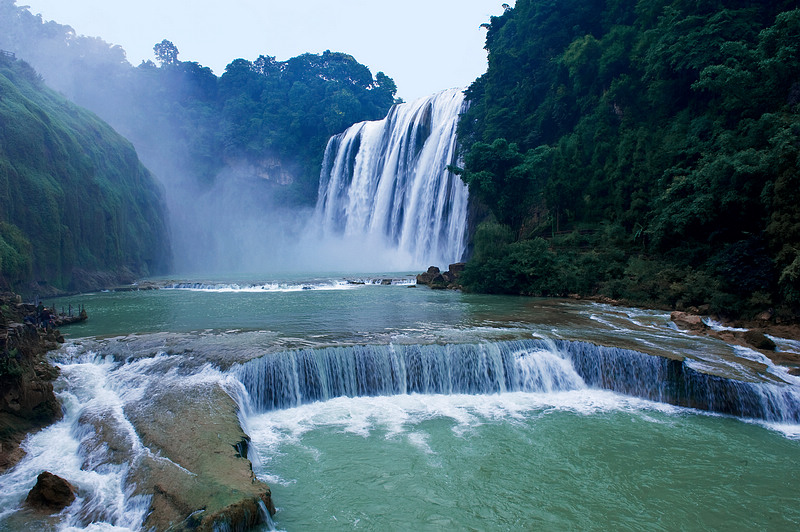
[[25, 0, 514, 100]]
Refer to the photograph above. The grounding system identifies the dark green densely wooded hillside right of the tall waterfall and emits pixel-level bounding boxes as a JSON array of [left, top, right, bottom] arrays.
[[460, 0, 800, 316]]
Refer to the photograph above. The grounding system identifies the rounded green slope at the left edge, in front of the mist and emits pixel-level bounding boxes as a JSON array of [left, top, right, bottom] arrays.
[[0, 55, 168, 291]]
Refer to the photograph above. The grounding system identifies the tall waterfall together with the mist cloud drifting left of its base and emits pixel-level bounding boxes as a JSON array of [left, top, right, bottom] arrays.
[[165, 89, 467, 274]]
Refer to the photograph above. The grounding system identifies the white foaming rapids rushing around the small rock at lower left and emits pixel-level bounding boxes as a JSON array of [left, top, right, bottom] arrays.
[[0, 355, 150, 531]]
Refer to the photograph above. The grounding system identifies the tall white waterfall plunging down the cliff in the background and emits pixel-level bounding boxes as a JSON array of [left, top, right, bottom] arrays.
[[314, 89, 467, 270]]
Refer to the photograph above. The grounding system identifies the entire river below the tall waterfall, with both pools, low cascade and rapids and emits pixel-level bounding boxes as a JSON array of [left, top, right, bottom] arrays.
[[0, 274, 800, 531]]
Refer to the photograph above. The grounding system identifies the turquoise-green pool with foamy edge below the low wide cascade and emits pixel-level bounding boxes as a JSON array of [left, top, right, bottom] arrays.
[[249, 392, 800, 531]]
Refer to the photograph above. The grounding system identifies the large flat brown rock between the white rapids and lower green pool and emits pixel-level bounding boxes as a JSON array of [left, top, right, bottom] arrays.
[[125, 383, 275, 532]]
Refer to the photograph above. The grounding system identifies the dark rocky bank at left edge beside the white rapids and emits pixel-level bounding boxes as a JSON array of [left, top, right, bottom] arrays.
[[0, 293, 63, 473]]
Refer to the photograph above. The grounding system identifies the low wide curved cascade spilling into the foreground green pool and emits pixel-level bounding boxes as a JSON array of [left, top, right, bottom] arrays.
[[233, 340, 800, 423]]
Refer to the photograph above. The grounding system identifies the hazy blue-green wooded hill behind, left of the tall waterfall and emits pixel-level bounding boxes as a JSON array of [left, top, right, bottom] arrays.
[[0, 0, 396, 203]]
